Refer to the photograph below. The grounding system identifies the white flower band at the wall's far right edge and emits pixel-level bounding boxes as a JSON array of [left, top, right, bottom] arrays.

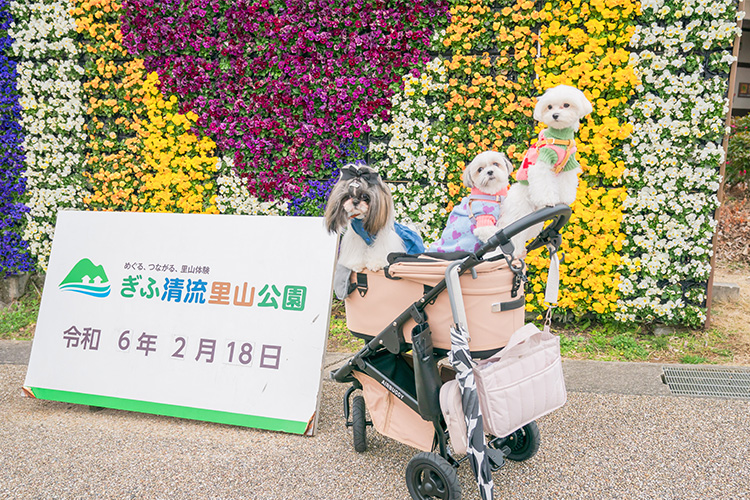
[[617, 4, 737, 326]]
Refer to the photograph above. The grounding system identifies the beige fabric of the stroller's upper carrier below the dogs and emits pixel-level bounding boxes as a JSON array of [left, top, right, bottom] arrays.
[[345, 255, 525, 352]]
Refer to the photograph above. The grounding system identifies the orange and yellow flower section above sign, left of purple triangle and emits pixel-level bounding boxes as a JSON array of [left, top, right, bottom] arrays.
[[71, 0, 218, 213]]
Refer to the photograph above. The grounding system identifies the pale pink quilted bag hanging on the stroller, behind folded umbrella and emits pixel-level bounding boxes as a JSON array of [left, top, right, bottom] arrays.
[[440, 324, 567, 453]]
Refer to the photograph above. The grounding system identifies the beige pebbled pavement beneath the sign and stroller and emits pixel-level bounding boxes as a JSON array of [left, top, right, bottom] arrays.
[[0, 341, 750, 500]]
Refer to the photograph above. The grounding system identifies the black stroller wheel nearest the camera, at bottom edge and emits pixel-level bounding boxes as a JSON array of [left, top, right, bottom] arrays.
[[406, 452, 461, 500]]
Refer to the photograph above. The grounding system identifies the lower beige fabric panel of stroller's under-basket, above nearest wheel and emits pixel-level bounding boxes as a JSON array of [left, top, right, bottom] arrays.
[[352, 371, 435, 451]]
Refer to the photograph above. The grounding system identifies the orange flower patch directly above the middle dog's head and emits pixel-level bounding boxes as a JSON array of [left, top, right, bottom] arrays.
[[442, 0, 539, 210]]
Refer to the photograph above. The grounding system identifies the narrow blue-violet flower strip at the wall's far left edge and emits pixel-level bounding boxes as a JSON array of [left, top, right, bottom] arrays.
[[0, 0, 32, 277]]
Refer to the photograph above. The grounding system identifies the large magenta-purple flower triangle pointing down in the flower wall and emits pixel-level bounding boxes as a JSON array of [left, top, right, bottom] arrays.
[[122, 0, 448, 200]]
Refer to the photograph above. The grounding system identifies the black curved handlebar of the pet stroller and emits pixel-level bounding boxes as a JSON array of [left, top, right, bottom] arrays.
[[476, 203, 571, 258]]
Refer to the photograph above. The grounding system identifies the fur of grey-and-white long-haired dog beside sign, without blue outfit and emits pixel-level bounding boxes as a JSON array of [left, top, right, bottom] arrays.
[[325, 165, 405, 272]]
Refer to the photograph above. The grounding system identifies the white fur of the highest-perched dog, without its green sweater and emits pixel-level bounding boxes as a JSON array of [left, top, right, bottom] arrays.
[[497, 85, 593, 258]]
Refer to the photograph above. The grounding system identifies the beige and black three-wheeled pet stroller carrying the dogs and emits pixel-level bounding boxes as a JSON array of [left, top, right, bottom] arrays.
[[331, 205, 571, 500]]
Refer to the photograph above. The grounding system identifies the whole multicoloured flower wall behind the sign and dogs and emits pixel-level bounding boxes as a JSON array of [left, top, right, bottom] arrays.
[[0, 0, 738, 325]]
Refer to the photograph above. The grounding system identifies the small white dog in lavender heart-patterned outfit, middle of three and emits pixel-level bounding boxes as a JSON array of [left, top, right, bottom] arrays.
[[428, 151, 513, 252]]
